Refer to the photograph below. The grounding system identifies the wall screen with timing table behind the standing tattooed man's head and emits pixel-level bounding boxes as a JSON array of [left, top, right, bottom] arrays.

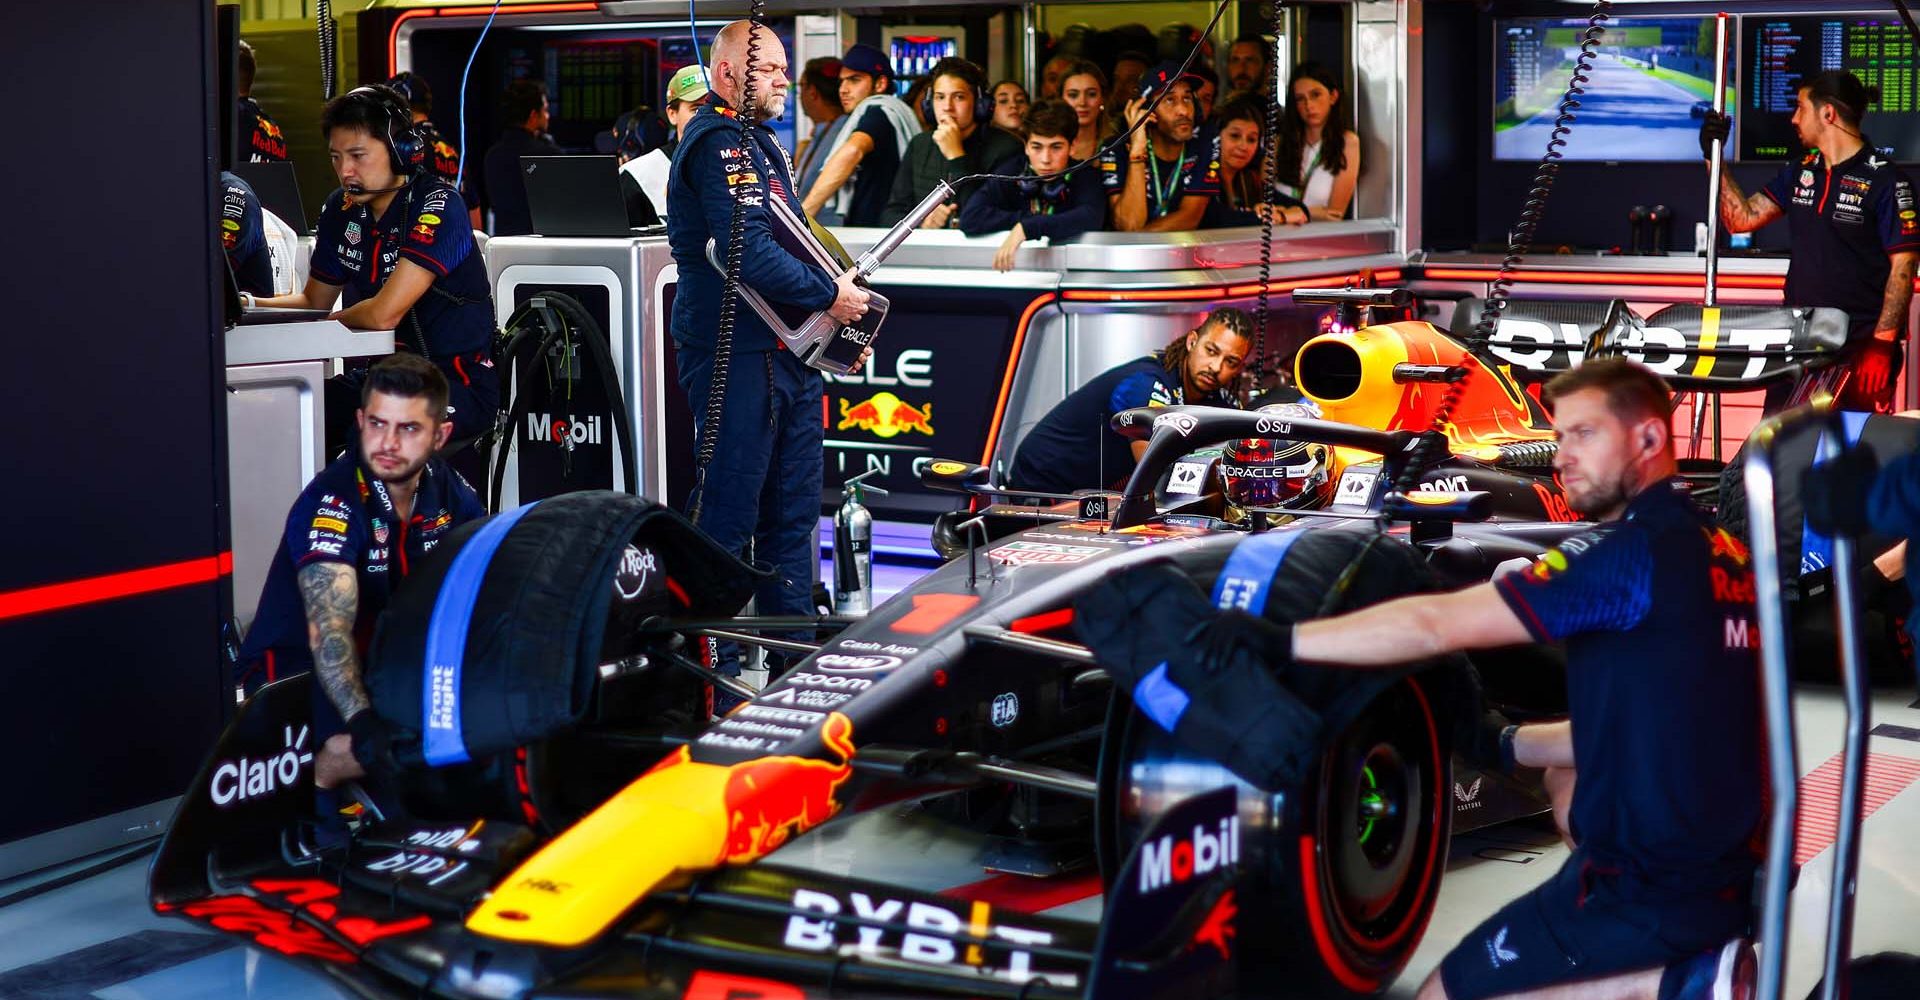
[[1734, 12, 1920, 161]]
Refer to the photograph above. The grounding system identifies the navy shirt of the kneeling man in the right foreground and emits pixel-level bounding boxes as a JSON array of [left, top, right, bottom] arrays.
[[1494, 484, 1766, 896]]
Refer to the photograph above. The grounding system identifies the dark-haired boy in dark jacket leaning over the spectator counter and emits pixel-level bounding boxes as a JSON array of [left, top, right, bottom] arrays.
[[960, 100, 1106, 271]]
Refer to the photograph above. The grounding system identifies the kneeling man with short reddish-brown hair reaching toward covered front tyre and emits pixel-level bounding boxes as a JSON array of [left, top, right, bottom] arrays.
[[1254, 359, 1766, 1000]]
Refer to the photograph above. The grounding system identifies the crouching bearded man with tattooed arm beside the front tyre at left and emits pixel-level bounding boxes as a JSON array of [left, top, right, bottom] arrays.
[[240, 355, 486, 789]]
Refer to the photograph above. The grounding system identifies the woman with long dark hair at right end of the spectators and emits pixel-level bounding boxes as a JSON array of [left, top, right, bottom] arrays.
[[1277, 63, 1359, 221]]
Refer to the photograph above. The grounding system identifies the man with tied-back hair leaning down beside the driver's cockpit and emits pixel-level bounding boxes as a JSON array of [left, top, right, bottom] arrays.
[[1008, 307, 1254, 493]]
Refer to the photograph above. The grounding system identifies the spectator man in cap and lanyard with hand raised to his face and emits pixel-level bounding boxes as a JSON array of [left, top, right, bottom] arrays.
[[1100, 63, 1219, 232]]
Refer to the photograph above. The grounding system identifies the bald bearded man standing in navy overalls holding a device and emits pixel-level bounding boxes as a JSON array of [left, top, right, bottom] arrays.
[[666, 21, 868, 674]]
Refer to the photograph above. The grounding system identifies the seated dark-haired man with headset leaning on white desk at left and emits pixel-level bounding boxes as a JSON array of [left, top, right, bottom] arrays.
[[259, 86, 499, 476]]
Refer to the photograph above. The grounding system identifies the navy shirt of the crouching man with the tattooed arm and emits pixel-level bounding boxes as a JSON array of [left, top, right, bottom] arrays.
[[240, 449, 486, 668]]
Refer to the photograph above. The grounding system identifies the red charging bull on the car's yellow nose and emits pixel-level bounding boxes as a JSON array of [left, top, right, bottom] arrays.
[[718, 712, 854, 864]]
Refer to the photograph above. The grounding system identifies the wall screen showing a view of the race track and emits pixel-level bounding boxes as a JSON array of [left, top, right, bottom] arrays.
[[1494, 17, 1736, 161]]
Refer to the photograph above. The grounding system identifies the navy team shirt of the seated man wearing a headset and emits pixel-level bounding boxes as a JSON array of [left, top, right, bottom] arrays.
[[309, 173, 493, 363]]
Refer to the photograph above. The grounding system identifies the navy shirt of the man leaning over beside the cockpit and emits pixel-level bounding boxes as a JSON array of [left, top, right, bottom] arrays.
[[1010, 355, 1233, 493]]
